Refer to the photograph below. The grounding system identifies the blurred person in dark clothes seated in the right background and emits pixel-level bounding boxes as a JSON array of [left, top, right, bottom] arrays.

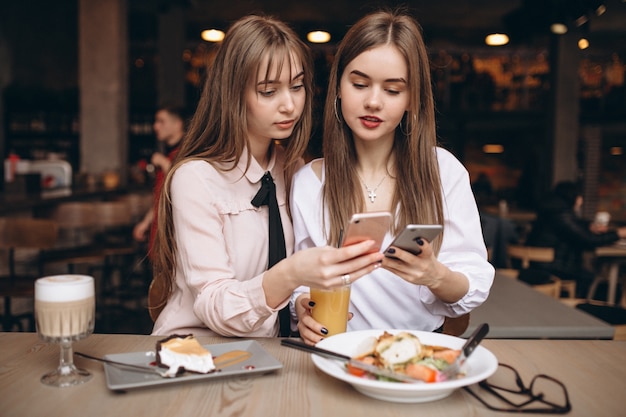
[[526, 181, 626, 298]]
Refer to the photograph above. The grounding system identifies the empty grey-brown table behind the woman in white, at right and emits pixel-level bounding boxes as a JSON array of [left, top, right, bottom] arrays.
[[463, 270, 614, 339]]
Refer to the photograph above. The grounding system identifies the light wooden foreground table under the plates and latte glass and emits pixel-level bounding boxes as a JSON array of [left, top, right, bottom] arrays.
[[0, 333, 626, 417]]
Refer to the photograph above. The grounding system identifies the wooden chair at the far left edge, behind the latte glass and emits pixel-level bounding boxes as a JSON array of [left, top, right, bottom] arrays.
[[0, 217, 58, 332]]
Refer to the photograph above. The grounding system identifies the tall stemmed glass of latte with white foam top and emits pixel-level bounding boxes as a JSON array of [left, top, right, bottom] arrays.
[[35, 275, 96, 387]]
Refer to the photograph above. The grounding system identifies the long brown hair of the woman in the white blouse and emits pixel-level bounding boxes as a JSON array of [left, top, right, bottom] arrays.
[[323, 10, 443, 252]]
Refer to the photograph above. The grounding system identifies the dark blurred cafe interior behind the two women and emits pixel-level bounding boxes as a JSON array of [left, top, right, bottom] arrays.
[[0, 0, 626, 333]]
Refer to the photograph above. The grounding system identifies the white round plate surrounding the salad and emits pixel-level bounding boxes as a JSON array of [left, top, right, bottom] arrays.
[[311, 330, 498, 403]]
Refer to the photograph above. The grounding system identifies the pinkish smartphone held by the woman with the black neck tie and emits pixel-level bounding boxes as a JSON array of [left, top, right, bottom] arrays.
[[340, 211, 391, 252]]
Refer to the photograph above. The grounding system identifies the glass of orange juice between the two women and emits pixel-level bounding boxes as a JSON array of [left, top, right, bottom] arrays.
[[310, 284, 350, 336]]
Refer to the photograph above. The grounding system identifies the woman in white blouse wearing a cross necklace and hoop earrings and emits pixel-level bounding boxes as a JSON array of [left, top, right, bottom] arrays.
[[291, 11, 494, 344]]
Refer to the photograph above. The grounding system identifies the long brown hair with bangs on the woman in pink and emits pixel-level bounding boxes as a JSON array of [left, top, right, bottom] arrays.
[[150, 15, 313, 309]]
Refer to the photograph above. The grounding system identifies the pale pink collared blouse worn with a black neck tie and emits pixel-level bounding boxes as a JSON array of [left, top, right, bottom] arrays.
[[152, 147, 294, 337]]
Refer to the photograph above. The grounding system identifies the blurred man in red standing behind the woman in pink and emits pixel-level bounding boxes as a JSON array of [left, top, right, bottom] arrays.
[[133, 105, 185, 249]]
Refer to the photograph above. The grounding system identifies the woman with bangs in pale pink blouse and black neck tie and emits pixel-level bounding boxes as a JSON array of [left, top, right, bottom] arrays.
[[151, 16, 382, 337]]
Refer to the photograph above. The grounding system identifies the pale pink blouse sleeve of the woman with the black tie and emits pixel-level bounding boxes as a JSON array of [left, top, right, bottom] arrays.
[[171, 161, 278, 336]]
